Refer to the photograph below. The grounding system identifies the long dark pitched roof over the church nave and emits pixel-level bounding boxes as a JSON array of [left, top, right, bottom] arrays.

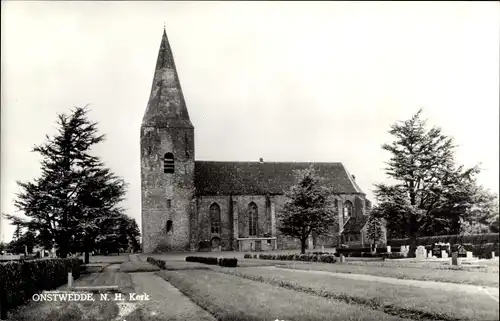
[[195, 161, 364, 195]]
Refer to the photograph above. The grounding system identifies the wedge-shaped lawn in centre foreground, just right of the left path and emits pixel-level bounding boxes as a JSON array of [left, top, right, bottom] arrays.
[[157, 270, 410, 321]]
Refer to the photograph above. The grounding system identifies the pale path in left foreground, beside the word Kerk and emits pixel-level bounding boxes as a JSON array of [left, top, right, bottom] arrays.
[[130, 272, 215, 321]]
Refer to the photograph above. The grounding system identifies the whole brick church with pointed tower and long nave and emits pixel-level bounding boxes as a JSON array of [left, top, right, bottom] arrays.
[[141, 30, 378, 253]]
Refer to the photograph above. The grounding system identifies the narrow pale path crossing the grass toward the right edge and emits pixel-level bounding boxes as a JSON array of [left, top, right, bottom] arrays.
[[272, 267, 499, 302]]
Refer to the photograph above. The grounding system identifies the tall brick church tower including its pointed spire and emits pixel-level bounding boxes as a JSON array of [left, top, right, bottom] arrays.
[[141, 30, 194, 253]]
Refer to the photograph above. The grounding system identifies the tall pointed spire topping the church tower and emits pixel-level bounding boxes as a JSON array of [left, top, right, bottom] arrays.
[[142, 29, 193, 128]]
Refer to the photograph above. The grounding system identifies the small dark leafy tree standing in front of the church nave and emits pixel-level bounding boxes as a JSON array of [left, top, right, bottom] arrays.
[[276, 168, 337, 254]]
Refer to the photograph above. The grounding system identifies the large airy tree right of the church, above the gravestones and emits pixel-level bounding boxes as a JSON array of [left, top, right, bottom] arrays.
[[374, 110, 490, 247]]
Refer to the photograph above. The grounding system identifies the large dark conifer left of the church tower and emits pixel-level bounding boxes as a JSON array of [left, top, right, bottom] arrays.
[[8, 107, 129, 262]]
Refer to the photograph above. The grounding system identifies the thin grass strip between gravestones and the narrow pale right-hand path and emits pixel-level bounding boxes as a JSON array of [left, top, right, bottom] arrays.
[[270, 259, 499, 287]]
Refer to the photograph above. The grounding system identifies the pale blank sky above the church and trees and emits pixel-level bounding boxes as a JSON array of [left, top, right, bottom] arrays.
[[1, 1, 500, 241]]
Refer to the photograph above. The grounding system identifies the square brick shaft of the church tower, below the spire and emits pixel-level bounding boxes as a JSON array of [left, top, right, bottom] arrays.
[[141, 127, 194, 253]]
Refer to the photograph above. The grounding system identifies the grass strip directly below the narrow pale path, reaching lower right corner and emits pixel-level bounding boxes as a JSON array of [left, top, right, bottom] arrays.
[[221, 268, 499, 320]]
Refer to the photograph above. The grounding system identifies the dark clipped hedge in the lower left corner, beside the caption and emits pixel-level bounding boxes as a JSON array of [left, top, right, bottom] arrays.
[[0, 258, 83, 319]]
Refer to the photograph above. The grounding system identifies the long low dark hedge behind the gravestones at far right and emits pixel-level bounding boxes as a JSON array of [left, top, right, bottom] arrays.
[[387, 233, 500, 246]]
